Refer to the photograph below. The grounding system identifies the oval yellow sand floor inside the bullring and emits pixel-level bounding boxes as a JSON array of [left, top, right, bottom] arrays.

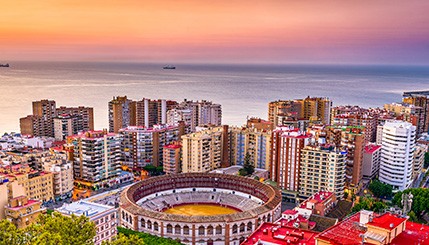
[[164, 204, 238, 216]]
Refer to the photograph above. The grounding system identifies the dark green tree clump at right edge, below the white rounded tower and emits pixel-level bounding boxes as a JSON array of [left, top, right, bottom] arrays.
[[392, 188, 429, 219]]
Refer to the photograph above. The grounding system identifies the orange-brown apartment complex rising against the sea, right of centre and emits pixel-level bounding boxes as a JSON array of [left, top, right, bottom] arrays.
[[268, 97, 332, 127]]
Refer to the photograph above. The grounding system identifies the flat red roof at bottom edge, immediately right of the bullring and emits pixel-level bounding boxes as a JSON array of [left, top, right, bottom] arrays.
[[241, 223, 318, 245]]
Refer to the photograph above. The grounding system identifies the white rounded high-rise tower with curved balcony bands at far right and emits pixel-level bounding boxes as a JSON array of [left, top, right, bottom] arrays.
[[379, 120, 416, 191]]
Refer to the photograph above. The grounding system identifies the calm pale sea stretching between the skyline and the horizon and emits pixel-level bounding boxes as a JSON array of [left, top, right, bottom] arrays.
[[0, 62, 429, 133]]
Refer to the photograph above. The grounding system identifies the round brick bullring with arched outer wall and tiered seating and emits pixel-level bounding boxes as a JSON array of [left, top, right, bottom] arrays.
[[119, 173, 281, 245]]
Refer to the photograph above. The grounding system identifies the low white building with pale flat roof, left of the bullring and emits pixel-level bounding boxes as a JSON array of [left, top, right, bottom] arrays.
[[56, 201, 118, 245]]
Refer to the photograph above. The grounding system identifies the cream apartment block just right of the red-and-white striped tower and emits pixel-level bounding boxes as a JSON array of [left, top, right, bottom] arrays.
[[299, 145, 347, 199]]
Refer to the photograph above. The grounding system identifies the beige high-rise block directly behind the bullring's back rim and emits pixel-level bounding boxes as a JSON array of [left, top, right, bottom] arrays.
[[182, 127, 228, 173]]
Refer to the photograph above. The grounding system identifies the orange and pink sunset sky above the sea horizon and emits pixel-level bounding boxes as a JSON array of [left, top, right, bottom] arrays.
[[0, 0, 429, 65]]
